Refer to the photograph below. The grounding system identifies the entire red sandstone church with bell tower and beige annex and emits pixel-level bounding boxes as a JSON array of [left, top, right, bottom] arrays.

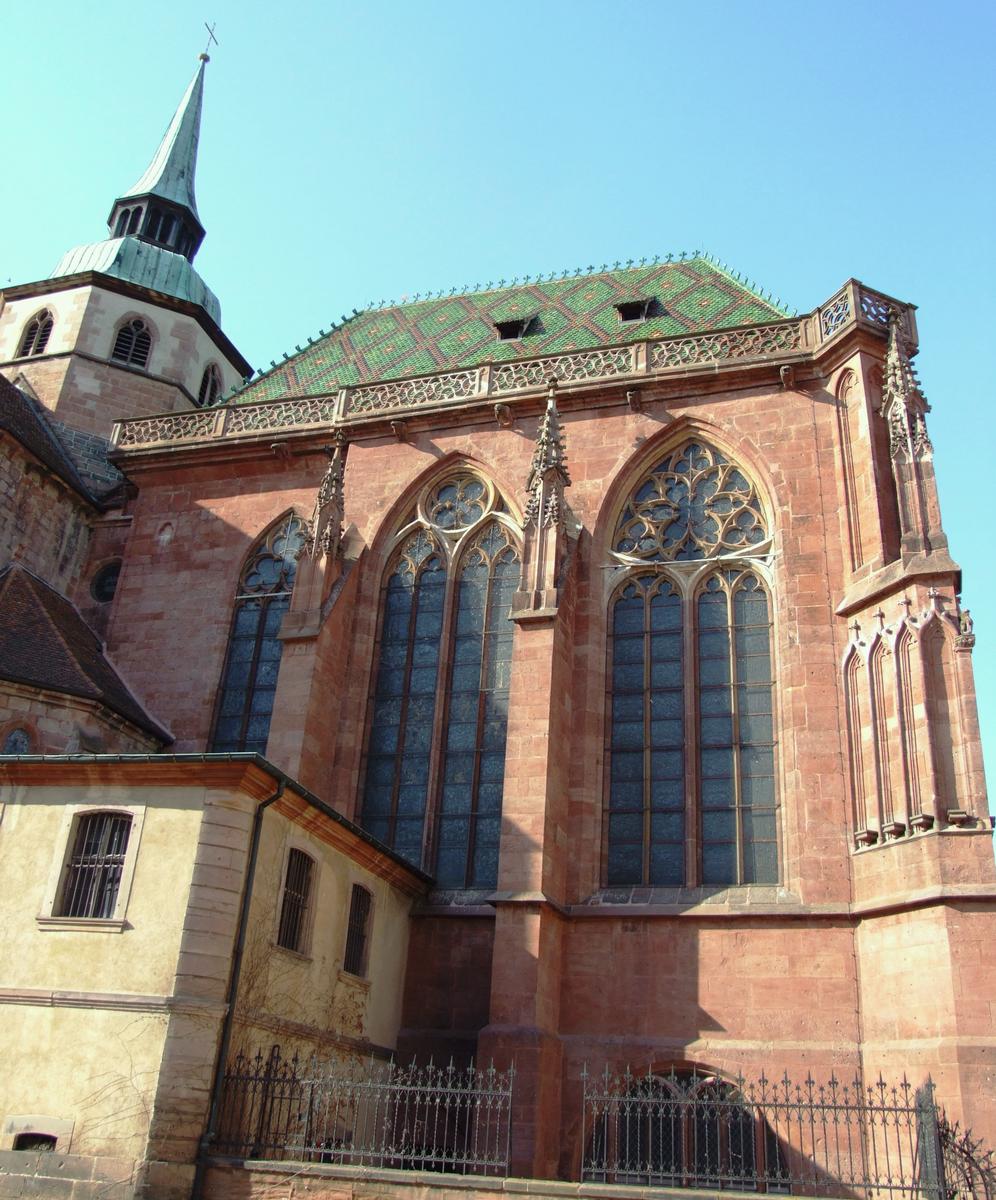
[[0, 56, 996, 1200]]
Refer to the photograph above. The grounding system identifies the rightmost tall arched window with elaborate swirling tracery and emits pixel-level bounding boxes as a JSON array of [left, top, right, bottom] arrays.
[[605, 440, 778, 887]]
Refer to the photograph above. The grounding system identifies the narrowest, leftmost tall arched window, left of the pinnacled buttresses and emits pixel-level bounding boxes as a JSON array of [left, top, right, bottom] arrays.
[[211, 515, 307, 754]]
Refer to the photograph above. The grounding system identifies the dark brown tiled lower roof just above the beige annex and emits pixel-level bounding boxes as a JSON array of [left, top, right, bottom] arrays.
[[0, 563, 173, 743]]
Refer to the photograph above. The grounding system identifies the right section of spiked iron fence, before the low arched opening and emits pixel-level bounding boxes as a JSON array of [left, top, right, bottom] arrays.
[[581, 1067, 996, 1200]]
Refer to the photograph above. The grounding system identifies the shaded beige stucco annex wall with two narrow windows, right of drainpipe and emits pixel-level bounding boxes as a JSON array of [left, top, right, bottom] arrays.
[[235, 810, 412, 1052]]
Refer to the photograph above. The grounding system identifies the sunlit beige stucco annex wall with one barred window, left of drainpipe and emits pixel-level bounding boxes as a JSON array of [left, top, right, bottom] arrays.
[[0, 785, 203, 1158]]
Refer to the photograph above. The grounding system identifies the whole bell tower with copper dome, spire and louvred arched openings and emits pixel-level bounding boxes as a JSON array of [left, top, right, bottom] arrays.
[[0, 54, 251, 438]]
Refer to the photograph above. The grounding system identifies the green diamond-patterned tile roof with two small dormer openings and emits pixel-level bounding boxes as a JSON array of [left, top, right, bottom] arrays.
[[236, 254, 787, 403]]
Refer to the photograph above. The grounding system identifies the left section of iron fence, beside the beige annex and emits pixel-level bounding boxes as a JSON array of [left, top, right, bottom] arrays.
[[214, 1046, 515, 1176]]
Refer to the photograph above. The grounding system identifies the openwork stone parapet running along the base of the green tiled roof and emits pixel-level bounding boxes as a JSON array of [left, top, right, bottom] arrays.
[[112, 280, 916, 450]]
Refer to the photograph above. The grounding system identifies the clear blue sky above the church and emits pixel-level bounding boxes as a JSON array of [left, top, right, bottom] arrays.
[[0, 0, 996, 806]]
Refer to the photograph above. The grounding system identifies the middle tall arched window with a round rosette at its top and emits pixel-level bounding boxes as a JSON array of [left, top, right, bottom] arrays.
[[362, 473, 520, 888]]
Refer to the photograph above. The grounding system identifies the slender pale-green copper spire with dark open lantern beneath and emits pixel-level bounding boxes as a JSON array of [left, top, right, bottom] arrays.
[[108, 54, 209, 262]]
